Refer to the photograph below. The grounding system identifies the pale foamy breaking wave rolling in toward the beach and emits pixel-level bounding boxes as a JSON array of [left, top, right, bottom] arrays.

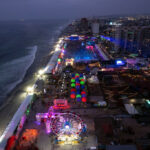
[[0, 46, 38, 100]]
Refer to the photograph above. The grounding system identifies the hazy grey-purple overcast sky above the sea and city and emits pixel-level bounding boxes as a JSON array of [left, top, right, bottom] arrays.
[[0, 0, 150, 20]]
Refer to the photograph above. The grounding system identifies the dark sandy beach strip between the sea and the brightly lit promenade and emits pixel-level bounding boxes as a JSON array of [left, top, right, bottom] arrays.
[[0, 20, 66, 136]]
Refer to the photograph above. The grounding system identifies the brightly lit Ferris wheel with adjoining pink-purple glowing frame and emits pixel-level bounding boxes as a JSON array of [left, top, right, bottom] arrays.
[[36, 105, 85, 144]]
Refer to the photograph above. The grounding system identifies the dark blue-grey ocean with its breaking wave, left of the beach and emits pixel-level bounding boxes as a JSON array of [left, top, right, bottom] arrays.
[[0, 20, 68, 105]]
